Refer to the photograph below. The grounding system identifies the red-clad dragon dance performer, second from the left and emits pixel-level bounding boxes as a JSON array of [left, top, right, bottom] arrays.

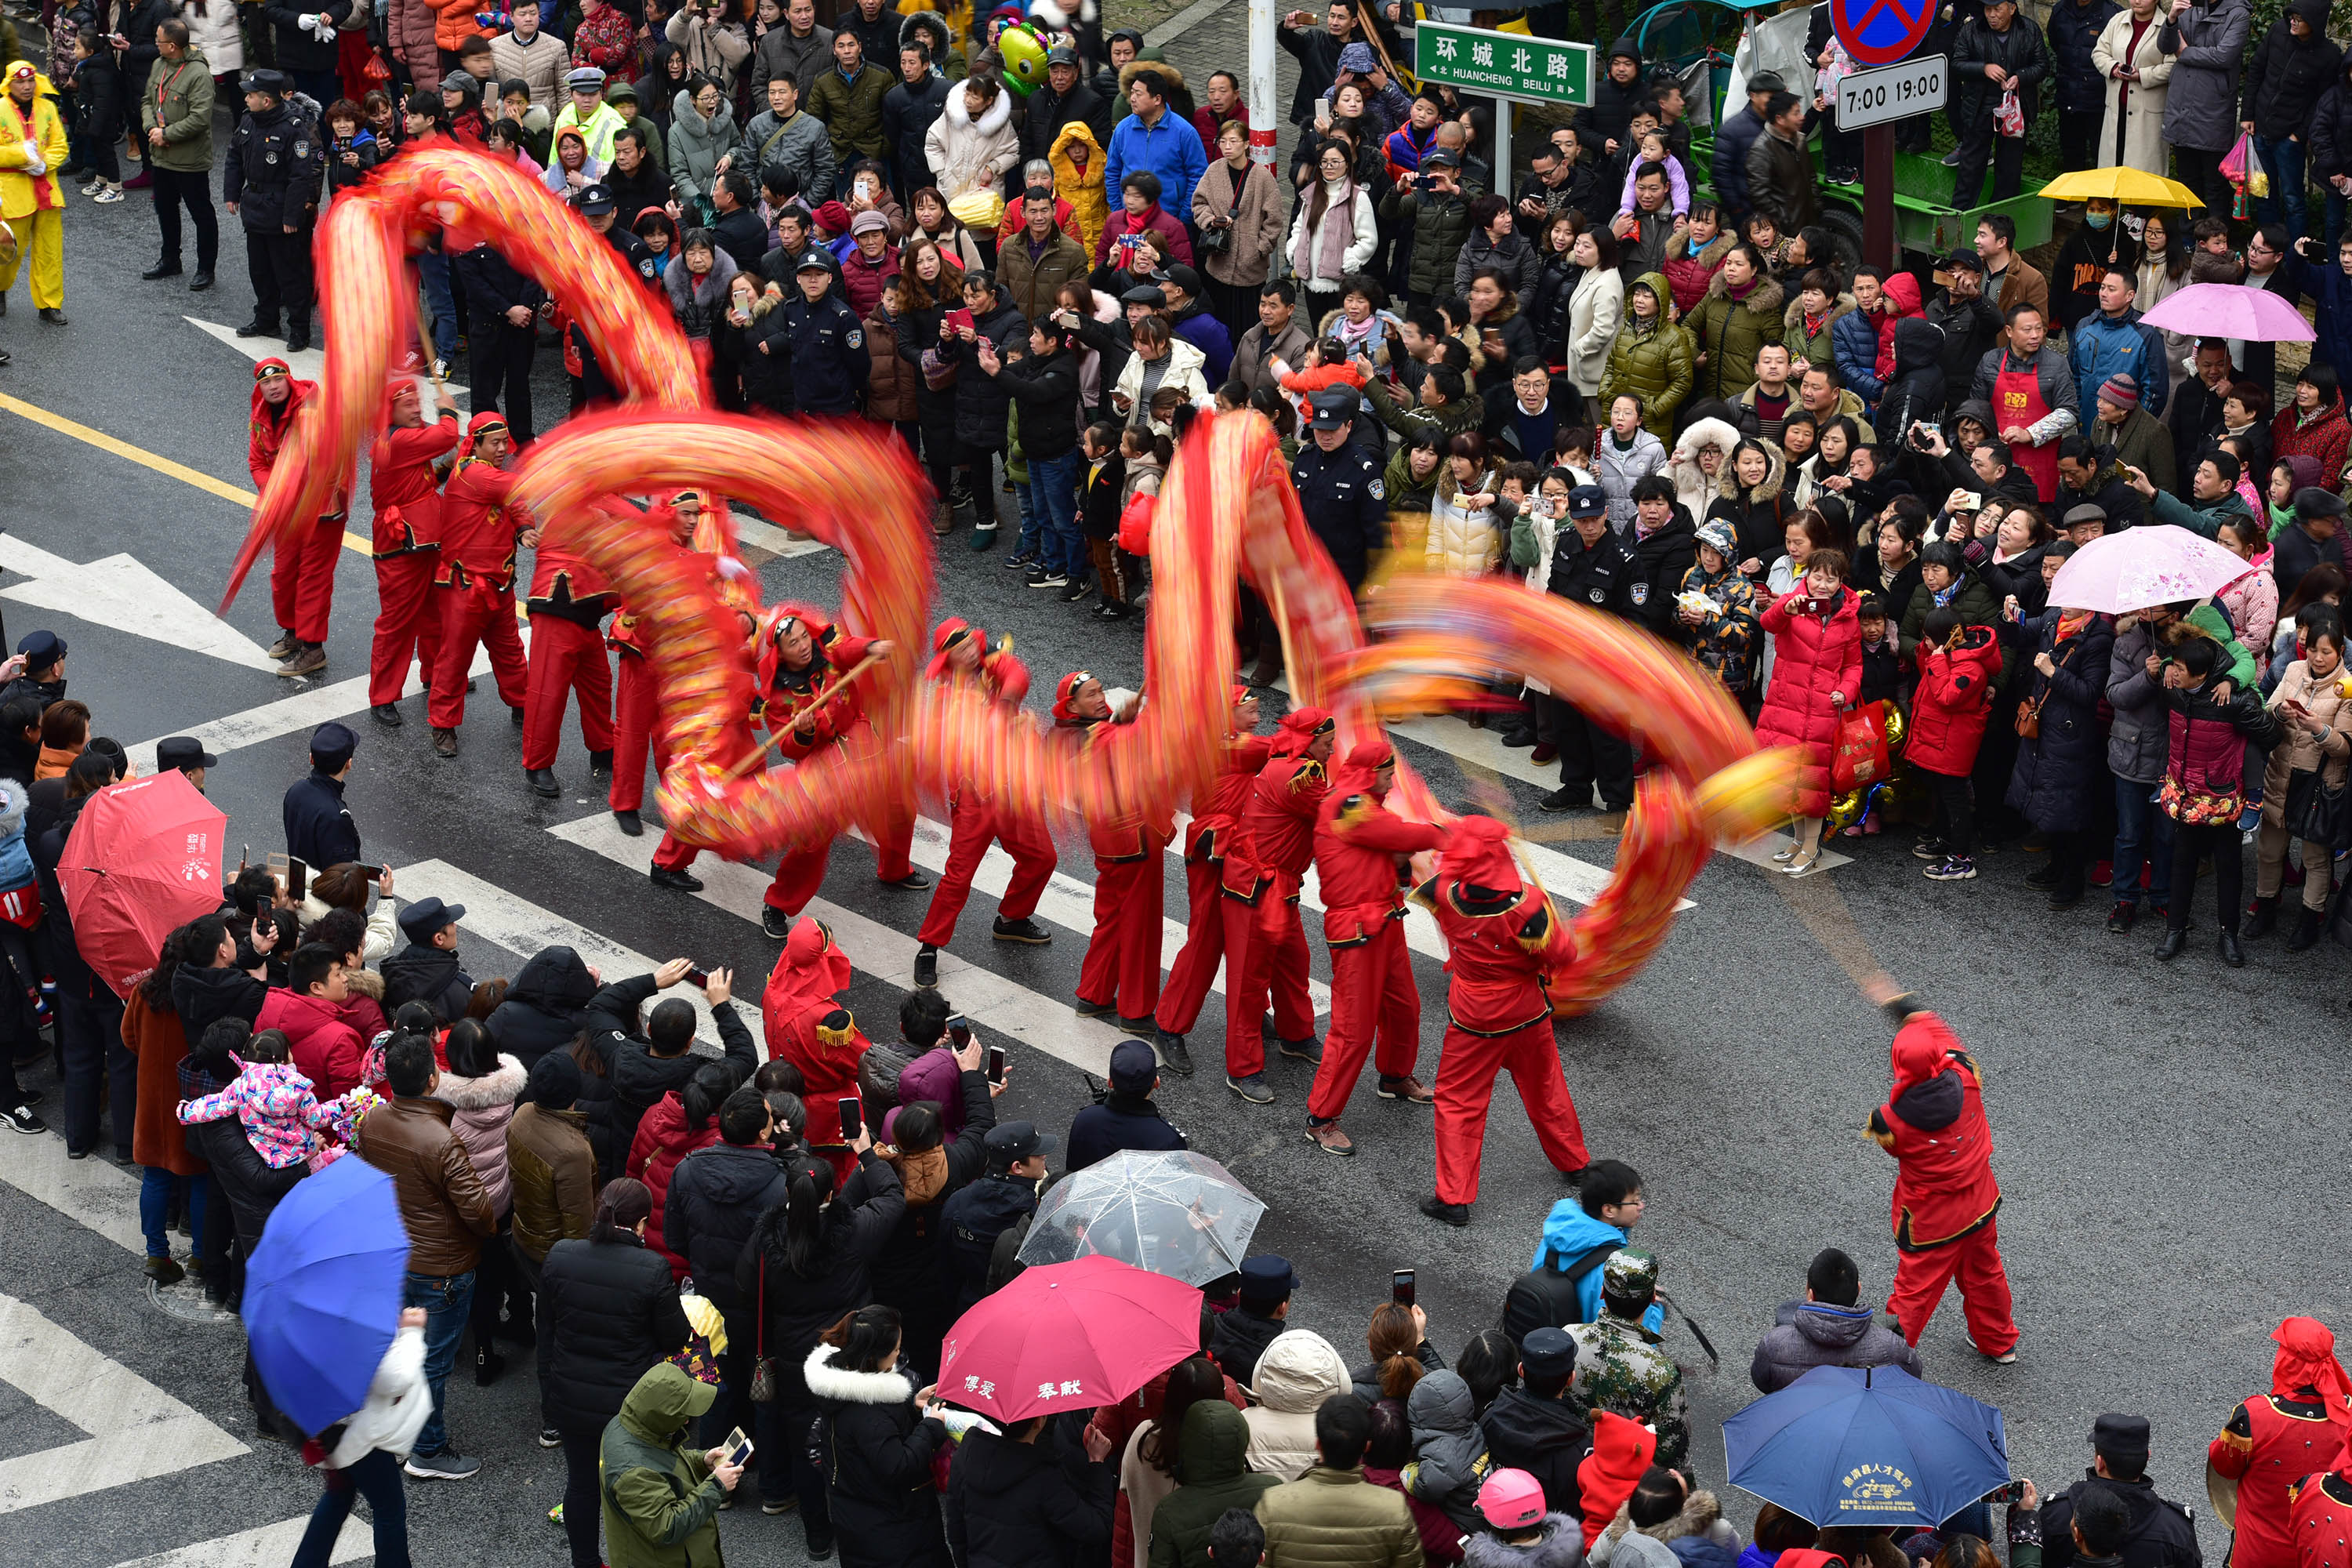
[[367, 390, 466, 724]]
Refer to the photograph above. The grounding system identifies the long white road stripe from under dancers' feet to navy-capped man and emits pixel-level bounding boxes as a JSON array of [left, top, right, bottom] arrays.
[[555, 811, 1129, 1076]]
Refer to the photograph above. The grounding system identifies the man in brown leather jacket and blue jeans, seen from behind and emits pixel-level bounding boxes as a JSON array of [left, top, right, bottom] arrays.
[[350, 1034, 499, 1481]]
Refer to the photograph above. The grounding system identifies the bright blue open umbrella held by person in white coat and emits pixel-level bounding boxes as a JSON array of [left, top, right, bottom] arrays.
[[245, 1154, 409, 1434]]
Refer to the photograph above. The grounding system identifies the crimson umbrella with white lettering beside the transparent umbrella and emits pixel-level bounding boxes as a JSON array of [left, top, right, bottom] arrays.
[[938, 1255, 1200, 1422]]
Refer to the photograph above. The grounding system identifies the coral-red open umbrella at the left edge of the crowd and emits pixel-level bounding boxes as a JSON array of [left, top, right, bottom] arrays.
[[56, 769, 228, 996]]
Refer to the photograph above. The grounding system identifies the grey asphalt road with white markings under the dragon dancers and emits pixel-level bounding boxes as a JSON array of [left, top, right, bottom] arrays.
[[0, 131, 2352, 1568]]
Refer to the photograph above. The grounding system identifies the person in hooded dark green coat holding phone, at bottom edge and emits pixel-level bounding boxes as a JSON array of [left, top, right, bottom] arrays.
[[597, 1361, 727, 1568]]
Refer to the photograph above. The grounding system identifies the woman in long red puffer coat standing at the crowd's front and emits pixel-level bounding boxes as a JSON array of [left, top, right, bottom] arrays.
[[1757, 550, 1863, 877]]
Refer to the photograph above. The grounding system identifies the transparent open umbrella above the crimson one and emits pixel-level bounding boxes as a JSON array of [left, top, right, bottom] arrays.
[[1021, 1149, 1265, 1286]]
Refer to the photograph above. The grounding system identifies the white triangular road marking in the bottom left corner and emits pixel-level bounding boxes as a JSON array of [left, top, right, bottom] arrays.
[[0, 1295, 252, 1514]]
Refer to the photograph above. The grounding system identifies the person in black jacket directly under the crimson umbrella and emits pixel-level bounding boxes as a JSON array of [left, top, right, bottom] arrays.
[[948, 1415, 1120, 1568]]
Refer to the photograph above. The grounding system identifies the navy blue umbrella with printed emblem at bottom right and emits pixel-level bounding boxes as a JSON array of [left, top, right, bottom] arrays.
[[1724, 1366, 2009, 1528]]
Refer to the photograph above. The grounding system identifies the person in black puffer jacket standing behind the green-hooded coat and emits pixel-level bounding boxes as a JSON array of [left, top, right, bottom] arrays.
[[539, 1175, 694, 1568]]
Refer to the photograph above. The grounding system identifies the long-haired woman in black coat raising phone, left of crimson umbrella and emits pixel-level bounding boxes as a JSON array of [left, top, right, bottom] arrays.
[[736, 1128, 906, 1559]]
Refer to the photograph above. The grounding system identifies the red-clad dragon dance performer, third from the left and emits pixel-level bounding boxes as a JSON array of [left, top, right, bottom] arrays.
[[426, 409, 532, 743]]
